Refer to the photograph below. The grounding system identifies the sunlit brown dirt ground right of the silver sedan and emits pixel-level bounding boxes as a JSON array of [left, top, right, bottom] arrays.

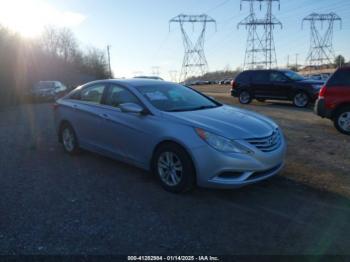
[[195, 85, 350, 197]]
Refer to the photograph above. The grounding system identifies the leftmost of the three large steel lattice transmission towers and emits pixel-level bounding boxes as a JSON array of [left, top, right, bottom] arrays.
[[169, 14, 216, 81]]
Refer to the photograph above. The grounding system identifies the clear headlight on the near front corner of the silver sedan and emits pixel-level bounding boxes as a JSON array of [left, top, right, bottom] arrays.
[[196, 128, 252, 154]]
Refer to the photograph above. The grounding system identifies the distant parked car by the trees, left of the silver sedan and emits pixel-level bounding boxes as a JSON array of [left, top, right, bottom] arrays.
[[30, 81, 68, 100]]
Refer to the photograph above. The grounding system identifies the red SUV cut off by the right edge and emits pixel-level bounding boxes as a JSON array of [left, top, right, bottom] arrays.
[[315, 67, 350, 135]]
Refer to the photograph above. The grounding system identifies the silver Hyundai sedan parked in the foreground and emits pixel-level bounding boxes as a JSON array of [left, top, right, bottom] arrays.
[[54, 79, 286, 192]]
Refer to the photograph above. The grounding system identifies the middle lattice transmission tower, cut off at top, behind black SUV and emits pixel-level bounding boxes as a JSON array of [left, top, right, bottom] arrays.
[[238, 0, 282, 69]]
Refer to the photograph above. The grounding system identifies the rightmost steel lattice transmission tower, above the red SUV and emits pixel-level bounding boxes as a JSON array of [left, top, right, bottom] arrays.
[[302, 12, 342, 67]]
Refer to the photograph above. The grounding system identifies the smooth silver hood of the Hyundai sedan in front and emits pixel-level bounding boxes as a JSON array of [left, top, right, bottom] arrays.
[[164, 105, 278, 139]]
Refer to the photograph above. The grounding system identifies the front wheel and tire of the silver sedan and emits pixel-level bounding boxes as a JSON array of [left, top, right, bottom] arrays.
[[152, 143, 196, 193]]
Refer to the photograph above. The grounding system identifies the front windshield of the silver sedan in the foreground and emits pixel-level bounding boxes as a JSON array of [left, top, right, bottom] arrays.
[[138, 84, 221, 112]]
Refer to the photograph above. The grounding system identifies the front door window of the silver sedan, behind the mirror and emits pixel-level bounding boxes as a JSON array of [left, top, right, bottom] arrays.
[[105, 85, 140, 107]]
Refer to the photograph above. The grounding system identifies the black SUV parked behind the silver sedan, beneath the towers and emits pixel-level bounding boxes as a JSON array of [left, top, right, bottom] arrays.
[[231, 70, 324, 107]]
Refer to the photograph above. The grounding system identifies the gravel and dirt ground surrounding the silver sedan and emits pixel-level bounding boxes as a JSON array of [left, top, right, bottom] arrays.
[[0, 95, 350, 255]]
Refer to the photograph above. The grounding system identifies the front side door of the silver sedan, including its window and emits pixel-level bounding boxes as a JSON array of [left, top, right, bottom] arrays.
[[101, 84, 158, 166]]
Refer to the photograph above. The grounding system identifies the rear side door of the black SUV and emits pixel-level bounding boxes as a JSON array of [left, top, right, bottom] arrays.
[[251, 71, 272, 98]]
